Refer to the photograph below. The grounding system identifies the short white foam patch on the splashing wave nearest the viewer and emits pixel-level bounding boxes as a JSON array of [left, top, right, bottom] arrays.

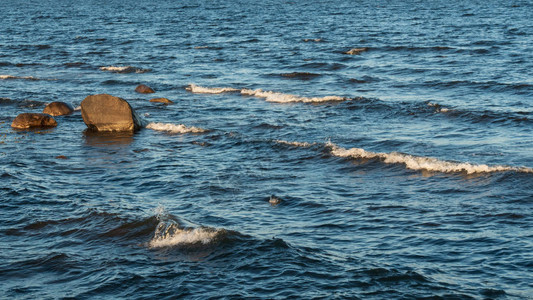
[[148, 227, 224, 248]]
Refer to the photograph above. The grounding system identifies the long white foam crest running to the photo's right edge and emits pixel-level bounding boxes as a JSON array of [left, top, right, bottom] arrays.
[[326, 142, 533, 174]]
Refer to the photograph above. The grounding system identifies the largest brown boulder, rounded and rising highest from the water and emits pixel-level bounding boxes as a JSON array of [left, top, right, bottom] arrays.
[[81, 94, 145, 131]]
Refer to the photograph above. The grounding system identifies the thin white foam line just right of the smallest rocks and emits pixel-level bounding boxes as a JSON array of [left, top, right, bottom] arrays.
[[185, 84, 352, 103]]
